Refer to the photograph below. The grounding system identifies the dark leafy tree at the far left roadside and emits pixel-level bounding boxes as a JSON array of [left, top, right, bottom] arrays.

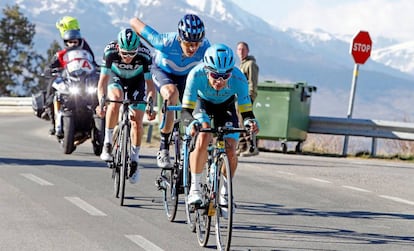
[[0, 4, 45, 96]]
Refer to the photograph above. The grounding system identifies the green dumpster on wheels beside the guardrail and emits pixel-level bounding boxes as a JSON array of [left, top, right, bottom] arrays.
[[253, 81, 316, 152]]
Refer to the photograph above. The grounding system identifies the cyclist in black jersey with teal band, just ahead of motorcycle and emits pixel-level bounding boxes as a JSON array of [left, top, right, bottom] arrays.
[[97, 28, 156, 183]]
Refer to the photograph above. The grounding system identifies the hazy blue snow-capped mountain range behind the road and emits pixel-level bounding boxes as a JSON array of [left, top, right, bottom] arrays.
[[0, 0, 414, 121]]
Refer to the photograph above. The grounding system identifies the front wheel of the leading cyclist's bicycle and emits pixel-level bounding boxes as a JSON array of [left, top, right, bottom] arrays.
[[215, 154, 233, 250]]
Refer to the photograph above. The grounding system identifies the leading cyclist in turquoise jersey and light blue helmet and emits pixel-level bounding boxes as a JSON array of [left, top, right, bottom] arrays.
[[181, 44, 259, 205]]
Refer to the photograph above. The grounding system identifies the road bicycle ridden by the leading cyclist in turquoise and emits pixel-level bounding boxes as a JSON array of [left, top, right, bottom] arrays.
[[195, 126, 255, 250]]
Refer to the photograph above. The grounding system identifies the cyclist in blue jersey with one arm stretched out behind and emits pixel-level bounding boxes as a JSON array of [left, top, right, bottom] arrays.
[[130, 14, 210, 168]]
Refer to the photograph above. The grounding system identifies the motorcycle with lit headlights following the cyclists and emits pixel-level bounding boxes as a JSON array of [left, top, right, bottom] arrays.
[[52, 49, 105, 155]]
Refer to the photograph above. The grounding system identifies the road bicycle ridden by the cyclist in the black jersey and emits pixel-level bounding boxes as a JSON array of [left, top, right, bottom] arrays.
[[105, 86, 153, 206]]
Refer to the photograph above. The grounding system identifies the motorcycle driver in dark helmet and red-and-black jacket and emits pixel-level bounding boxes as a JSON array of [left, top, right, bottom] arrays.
[[45, 30, 96, 137]]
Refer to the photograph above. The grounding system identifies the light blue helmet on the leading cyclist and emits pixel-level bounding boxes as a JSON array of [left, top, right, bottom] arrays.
[[203, 44, 234, 73]]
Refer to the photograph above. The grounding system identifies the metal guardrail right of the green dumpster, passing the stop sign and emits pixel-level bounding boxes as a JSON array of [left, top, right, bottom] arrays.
[[308, 116, 414, 156]]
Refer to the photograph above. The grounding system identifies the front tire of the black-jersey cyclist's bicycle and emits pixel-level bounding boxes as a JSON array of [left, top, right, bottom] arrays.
[[119, 122, 130, 206]]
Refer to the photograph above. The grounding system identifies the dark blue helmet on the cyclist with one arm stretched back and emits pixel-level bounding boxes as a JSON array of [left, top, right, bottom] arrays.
[[178, 14, 205, 42]]
